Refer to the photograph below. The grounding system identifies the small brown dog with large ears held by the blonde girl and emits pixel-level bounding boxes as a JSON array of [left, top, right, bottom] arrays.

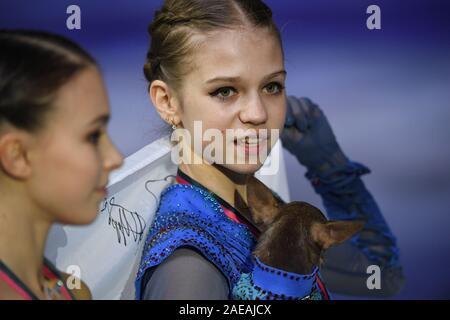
[[235, 177, 364, 274]]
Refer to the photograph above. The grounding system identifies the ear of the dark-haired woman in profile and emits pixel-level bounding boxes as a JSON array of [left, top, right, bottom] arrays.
[[0, 131, 31, 180]]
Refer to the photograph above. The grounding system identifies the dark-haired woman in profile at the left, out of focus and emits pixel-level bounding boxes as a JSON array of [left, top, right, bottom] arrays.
[[0, 30, 122, 300]]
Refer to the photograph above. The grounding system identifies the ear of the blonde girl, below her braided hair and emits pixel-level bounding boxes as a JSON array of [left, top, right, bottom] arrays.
[[149, 80, 181, 125]]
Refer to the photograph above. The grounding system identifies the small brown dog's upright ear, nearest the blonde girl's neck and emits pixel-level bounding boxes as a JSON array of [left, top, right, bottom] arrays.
[[243, 176, 282, 226]]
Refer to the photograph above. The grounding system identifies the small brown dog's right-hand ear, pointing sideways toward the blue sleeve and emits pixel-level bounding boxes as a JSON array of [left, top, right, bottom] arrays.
[[311, 220, 364, 250]]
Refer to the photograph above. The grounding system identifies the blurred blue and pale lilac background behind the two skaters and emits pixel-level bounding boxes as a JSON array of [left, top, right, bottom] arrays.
[[0, 0, 450, 299]]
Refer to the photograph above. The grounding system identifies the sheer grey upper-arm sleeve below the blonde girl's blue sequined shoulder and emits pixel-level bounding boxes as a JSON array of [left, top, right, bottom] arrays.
[[141, 248, 229, 300]]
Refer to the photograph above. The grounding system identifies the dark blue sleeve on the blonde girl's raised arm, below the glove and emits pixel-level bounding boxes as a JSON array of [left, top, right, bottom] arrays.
[[306, 161, 404, 296]]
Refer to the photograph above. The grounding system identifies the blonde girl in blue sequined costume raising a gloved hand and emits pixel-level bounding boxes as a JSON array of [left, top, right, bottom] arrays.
[[136, 0, 403, 299]]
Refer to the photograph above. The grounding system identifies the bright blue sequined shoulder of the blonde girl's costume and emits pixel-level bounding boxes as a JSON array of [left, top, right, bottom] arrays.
[[136, 184, 256, 299]]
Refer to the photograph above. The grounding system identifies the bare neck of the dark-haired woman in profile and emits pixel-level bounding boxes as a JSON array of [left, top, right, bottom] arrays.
[[0, 182, 51, 298]]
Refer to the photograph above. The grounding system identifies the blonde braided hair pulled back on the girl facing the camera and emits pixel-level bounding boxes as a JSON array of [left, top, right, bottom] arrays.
[[144, 0, 282, 88]]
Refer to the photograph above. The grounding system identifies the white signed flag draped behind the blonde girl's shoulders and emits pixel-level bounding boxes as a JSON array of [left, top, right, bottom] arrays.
[[45, 137, 289, 299]]
